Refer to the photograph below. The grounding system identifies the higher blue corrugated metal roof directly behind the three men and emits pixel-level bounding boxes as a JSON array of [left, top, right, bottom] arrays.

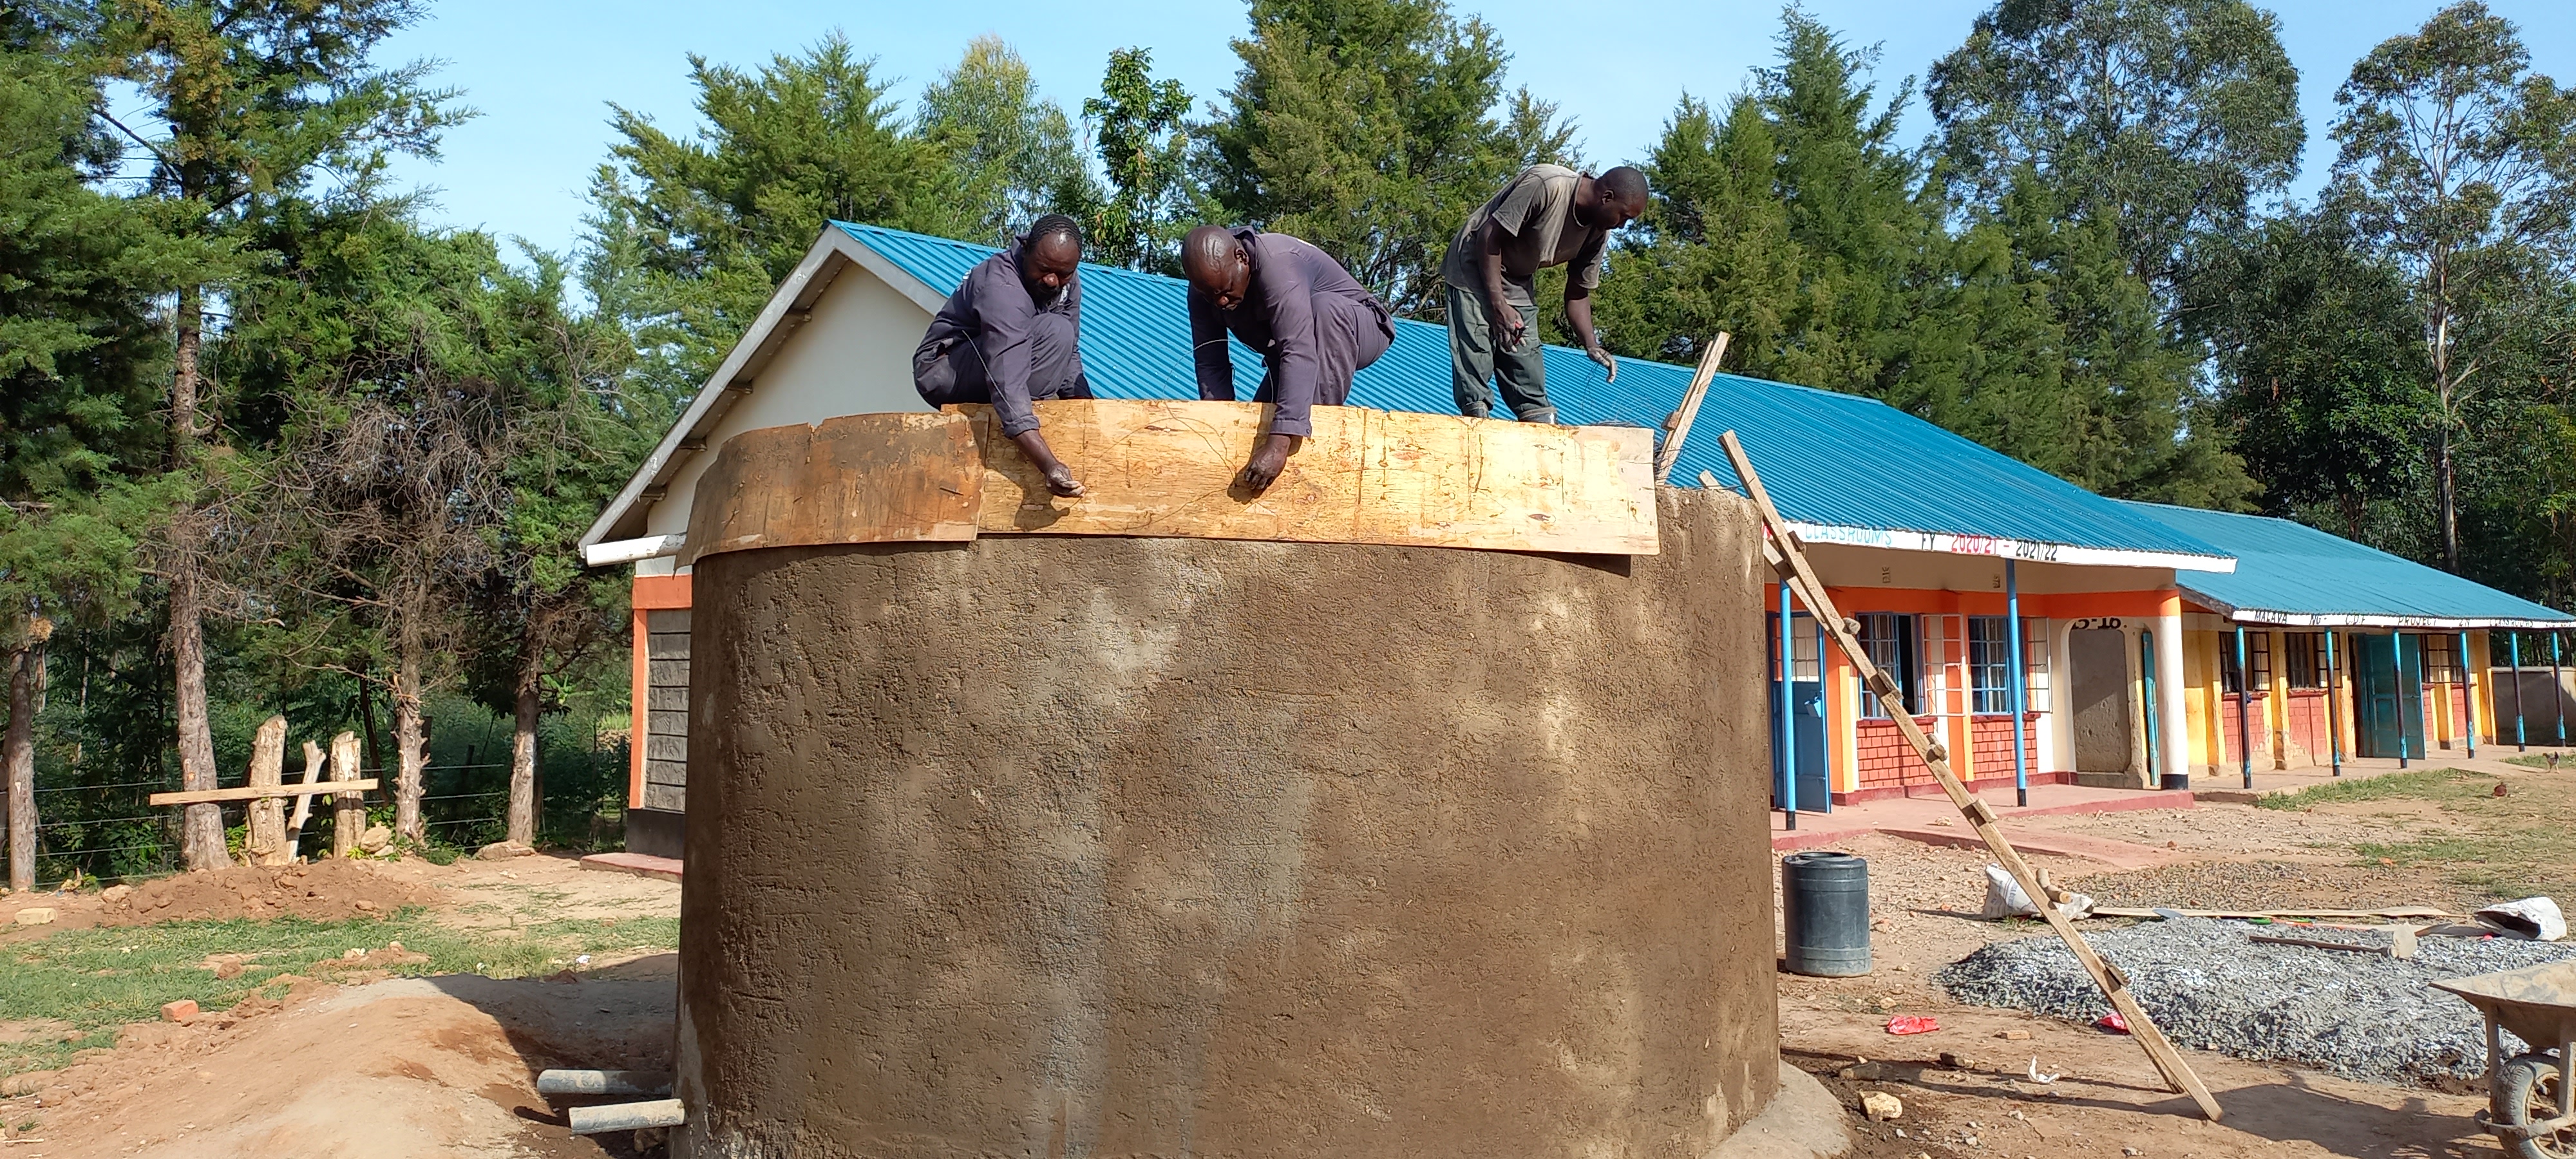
[[837, 221, 2228, 567]]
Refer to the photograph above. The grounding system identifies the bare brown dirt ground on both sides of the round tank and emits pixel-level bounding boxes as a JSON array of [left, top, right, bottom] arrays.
[[0, 773, 2576, 1159]]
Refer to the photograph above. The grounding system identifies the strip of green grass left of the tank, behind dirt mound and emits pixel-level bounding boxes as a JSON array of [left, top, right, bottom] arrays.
[[0, 909, 680, 1074]]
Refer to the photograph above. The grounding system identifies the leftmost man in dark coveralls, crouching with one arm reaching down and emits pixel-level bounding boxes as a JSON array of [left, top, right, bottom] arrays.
[[912, 214, 1092, 495]]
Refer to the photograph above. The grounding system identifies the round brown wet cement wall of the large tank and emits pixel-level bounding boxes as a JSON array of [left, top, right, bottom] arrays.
[[675, 489, 1777, 1159]]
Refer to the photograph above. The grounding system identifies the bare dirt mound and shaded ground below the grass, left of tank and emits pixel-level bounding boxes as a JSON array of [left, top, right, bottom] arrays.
[[13, 956, 675, 1159]]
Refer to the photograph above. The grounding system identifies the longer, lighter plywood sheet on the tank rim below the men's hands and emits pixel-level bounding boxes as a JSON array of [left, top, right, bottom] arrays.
[[948, 399, 1656, 556]]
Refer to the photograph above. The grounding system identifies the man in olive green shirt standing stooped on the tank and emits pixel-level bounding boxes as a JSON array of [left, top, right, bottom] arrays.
[[1440, 165, 1646, 422]]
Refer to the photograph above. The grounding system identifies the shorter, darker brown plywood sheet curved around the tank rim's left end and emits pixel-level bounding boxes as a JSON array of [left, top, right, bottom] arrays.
[[680, 412, 984, 564]]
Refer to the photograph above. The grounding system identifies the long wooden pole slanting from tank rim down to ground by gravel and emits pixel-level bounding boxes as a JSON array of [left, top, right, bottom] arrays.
[[1700, 430, 2221, 1120]]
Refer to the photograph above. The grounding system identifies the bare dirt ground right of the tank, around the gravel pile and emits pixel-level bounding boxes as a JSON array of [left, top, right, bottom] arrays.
[[1780, 775, 2576, 1159]]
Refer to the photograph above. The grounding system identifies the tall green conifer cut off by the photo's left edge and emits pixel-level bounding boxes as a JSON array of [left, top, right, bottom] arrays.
[[0, 27, 191, 891]]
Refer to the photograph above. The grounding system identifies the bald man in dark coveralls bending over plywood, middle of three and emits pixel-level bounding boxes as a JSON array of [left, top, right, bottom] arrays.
[[1180, 224, 1396, 492]]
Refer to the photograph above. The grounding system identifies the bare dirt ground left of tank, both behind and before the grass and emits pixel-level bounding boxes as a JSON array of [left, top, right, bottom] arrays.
[[0, 855, 680, 1159]]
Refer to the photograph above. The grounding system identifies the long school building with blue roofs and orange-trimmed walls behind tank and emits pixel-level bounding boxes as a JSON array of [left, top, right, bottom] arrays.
[[582, 221, 2576, 858]]
